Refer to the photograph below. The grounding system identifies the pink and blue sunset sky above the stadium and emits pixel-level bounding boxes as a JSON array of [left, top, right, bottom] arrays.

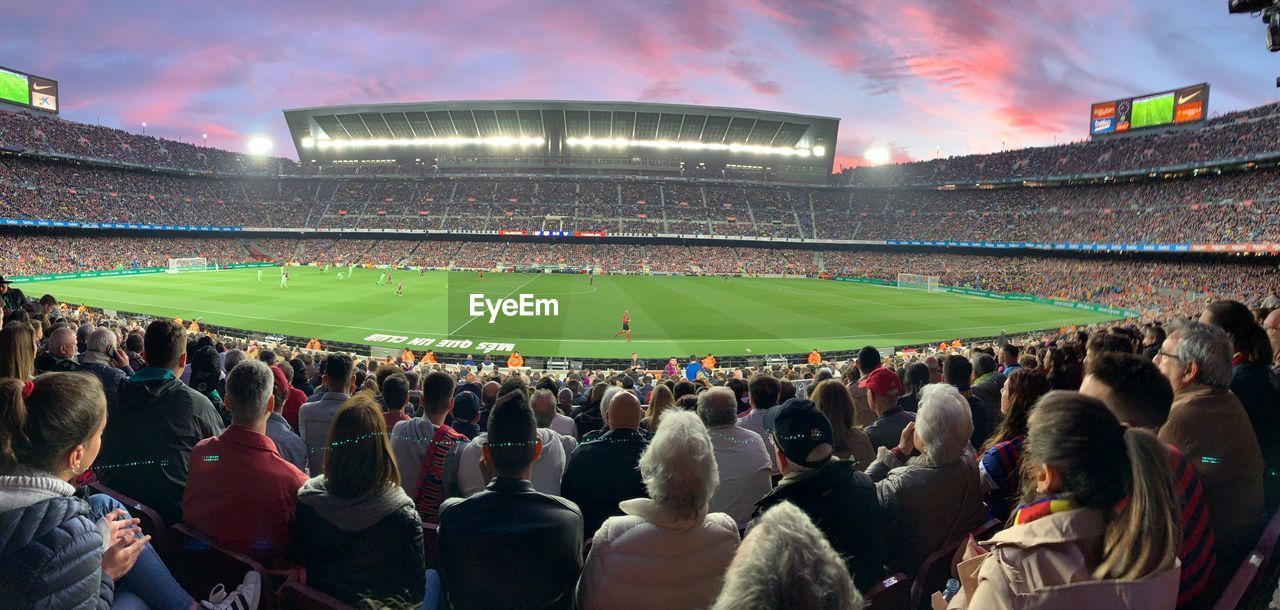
[[0, 0, 1280, 165]]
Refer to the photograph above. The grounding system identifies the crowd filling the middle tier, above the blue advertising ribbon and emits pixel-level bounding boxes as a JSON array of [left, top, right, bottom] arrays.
[[0, 146, 1280, 244]]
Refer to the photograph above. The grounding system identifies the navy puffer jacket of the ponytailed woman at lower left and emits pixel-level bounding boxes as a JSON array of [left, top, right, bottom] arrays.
[[0, 496, 115, 609]]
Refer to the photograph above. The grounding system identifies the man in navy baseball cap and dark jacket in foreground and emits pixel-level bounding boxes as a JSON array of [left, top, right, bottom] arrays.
[[748, 398, 887, 592]]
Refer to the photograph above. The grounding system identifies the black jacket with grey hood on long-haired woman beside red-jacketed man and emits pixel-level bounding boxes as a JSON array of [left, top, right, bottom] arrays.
[[292, 477, 426, 606]]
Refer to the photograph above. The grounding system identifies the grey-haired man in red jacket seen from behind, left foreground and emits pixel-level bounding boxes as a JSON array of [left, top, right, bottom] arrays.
[[182, 361, 307, 567]]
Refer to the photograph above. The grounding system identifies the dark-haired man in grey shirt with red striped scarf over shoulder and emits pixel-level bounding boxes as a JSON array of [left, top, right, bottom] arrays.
[[392, 371, 475, 523]]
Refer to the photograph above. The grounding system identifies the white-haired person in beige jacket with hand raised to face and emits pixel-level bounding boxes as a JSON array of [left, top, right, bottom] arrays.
[[867, 384, 987, 575]]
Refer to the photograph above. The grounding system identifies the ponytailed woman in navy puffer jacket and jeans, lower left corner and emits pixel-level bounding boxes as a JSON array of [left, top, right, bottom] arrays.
[[0, 372, 238, 609]]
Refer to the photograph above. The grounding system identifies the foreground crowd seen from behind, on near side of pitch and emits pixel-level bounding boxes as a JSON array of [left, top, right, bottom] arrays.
[[0, 282, 1280, 610]]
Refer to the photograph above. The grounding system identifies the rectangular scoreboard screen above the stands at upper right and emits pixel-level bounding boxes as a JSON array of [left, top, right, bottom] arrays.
[[1089, 83, 1208, 136]]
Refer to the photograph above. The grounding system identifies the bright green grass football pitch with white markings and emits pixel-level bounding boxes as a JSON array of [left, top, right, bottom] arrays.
[[17, 267, 1121, 359]]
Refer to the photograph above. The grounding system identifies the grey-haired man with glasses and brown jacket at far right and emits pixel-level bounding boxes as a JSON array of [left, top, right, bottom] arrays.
[[1156, 322, 1263, 565]]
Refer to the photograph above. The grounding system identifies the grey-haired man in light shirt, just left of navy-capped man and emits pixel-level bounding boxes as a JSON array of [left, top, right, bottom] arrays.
[[698, 387, 773, 529]]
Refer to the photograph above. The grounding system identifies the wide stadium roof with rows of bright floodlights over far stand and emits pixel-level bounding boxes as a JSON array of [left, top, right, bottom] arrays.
[[284, 100, 840, 179]]
